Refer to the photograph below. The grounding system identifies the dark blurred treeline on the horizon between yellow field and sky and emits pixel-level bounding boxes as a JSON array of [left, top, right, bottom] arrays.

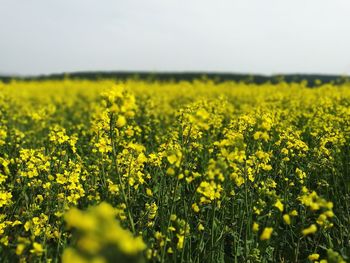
[[0, 71, 350, 87]]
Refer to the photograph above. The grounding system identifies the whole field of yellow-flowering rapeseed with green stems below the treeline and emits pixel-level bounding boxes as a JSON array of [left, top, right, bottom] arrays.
[[0, 79, 350, 263]]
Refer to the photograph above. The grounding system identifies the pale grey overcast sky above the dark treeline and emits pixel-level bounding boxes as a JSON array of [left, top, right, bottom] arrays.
[[0, 0, 350, 75]]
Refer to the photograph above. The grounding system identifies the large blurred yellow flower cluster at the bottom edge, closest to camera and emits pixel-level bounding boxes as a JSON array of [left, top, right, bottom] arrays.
[[62, 202, 146, 263]]
